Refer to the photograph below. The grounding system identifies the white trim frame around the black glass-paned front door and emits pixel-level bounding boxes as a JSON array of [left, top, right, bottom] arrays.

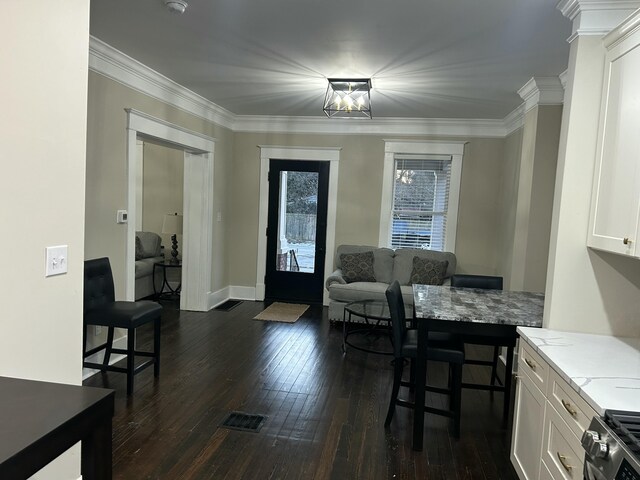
[[255, 145, 341, 305]]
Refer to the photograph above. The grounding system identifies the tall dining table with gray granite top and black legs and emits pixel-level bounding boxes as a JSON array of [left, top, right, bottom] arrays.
[[413, 284, 544, 451]]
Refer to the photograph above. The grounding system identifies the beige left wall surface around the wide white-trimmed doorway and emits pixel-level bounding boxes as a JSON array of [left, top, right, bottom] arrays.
[[85, 71, 233, 298]]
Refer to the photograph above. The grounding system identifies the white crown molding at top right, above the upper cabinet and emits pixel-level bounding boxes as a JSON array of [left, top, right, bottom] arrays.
[[556, 0, 640, 43]]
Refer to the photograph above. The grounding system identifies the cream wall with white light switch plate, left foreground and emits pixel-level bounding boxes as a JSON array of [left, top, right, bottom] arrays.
[[0, 0, 89, 479]]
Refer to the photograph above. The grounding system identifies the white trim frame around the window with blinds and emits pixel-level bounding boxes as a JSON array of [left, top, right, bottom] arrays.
[[378, 140, 467, 252]]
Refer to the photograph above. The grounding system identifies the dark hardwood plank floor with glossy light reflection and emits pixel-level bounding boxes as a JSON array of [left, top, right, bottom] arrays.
[[85, 301, 517, 480]]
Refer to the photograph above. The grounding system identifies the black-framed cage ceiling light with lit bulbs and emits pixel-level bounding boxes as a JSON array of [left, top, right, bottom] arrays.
[[322, 78, 371, 118]]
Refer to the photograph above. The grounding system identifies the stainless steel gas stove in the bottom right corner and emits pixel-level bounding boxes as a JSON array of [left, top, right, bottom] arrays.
[[582, 410, 640, 480]]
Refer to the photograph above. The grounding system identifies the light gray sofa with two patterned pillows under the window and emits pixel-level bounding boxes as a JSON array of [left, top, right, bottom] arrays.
[[325, 245, 456, 321]]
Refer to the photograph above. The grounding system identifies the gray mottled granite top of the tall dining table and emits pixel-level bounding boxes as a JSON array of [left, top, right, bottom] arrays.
[[413, 285, 544, 327]]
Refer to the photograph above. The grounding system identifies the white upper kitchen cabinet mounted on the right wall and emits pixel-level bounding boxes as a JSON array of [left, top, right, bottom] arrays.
[[587, 13, 640, 257]]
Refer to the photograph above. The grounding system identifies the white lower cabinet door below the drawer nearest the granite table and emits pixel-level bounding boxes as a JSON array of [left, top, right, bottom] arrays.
[[511, 374, 545, 480]]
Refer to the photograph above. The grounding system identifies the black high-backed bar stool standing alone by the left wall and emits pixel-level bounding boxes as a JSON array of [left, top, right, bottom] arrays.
[[82, 257, 162, 395]]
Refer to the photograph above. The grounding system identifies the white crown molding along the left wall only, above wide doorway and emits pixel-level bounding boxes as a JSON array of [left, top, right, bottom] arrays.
[[89, 36, 235, 128]]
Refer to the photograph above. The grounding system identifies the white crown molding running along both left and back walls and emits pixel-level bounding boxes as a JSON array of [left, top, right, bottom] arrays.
[[89, 36, 560, 138]]
